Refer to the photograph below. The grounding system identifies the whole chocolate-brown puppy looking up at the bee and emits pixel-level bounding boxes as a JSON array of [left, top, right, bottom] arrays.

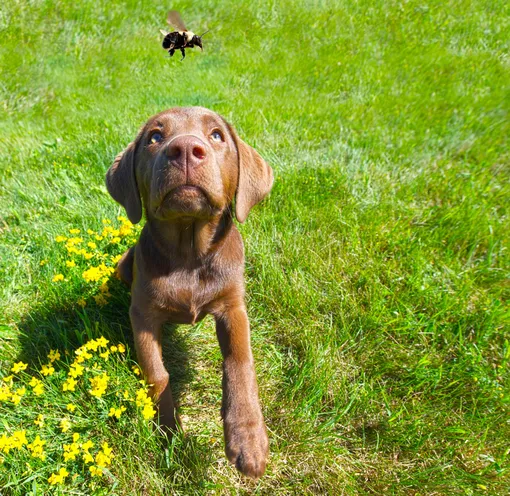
[[106, 107, 273, 478]]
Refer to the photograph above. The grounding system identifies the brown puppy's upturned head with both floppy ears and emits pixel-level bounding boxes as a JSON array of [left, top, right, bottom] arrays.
[[106, 107, 273, 227]]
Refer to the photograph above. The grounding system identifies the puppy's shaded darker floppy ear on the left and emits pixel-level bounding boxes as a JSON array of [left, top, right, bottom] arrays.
[[106, 138, 142, 224]]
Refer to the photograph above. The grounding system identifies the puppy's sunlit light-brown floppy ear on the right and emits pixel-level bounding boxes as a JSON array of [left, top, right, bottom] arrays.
[[231, 128, 274, 223]]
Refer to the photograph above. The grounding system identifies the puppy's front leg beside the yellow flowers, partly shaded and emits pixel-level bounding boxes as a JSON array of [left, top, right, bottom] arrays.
[[129, 305, 178, 430]]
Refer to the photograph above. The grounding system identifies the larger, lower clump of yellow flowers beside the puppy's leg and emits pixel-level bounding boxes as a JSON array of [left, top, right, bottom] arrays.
[[0, 336, 156, 491]]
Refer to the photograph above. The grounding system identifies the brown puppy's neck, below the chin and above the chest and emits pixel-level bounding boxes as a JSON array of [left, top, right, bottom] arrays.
[[147, 211, 232, 264]]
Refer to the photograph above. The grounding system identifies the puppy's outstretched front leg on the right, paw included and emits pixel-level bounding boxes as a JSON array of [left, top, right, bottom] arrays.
[[216, 303, 269, 478]]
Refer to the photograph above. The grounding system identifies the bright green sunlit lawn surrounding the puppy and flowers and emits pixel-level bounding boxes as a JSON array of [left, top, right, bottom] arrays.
[[0, 0, 510, 495]]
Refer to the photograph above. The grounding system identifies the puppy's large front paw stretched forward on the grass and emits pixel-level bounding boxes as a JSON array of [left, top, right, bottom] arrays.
[[225, 421, 269, 479]]
